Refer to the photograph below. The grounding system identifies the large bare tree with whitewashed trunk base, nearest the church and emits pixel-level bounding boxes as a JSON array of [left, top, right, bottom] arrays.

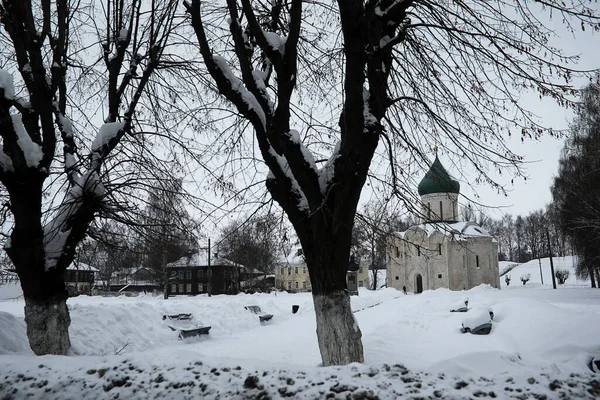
[[184, 0, 598, 365]]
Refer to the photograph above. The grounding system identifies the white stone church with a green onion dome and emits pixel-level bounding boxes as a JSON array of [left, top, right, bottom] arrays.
[[387, 154, 500, 293]]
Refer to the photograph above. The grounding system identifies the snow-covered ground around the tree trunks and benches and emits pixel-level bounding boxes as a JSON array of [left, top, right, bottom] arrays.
[[0, 284, 600, 399]]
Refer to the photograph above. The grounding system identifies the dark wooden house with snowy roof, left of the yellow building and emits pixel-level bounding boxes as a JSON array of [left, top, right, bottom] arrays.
[[165, 252, 244, 296]]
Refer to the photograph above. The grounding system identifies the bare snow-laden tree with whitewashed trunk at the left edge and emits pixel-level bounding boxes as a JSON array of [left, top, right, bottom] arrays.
[[0, 0, 177, 354]]
